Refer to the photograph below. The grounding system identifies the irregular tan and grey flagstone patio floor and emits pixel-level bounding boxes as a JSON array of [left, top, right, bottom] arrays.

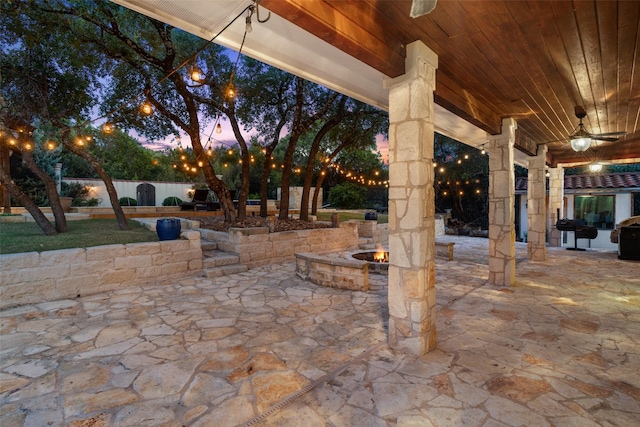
[[0, 237, 640, 427]]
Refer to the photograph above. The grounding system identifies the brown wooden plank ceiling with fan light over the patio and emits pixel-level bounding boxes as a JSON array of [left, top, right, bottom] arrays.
[[260, 0, 640, 165]]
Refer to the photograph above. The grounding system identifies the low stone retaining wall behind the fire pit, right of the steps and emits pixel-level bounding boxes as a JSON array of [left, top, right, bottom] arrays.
[[199, 221, 359, 268]]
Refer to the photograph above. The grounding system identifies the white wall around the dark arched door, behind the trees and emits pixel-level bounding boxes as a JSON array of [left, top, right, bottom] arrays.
[[62, 178, 193, 207]]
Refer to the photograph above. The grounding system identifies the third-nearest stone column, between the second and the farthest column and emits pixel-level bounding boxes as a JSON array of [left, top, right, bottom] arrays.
[[527, 145, 547, 261]]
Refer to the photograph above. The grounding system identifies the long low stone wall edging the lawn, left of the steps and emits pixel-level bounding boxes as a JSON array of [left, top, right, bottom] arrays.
[[0, 231, 202, 309]]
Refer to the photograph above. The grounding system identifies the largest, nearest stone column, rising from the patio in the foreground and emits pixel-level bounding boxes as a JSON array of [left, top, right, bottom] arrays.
[[384, 42, 438, 355]]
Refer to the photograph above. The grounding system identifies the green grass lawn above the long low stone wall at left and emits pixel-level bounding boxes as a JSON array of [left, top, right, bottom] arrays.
[[0, 219, 158, 254]]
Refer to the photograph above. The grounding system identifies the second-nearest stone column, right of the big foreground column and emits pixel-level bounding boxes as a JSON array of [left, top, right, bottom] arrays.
[[486, 118, 517, 286]]
